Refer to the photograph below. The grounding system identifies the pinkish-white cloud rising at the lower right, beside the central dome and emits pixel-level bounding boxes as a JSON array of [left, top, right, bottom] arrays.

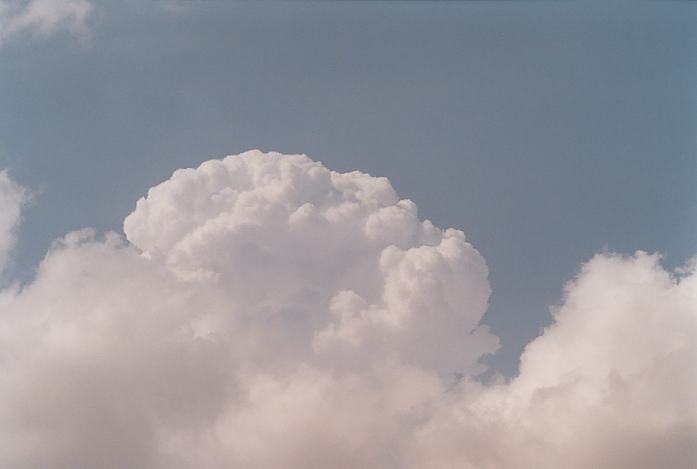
[[410, 252, 697, 469]]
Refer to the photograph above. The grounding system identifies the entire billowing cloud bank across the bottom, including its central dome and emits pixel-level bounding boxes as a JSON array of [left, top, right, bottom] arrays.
[[0, 151, 697, 469]]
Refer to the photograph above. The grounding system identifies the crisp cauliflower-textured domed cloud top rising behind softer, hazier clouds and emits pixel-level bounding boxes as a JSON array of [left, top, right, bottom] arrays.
[[124, 152, 497, 372]]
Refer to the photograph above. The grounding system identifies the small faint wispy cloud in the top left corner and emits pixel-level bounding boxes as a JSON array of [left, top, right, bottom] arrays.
[[0, 0, 94, 43]]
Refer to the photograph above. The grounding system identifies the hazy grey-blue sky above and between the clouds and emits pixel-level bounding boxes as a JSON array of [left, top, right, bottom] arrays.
[[0, 1, 697, 375]]
